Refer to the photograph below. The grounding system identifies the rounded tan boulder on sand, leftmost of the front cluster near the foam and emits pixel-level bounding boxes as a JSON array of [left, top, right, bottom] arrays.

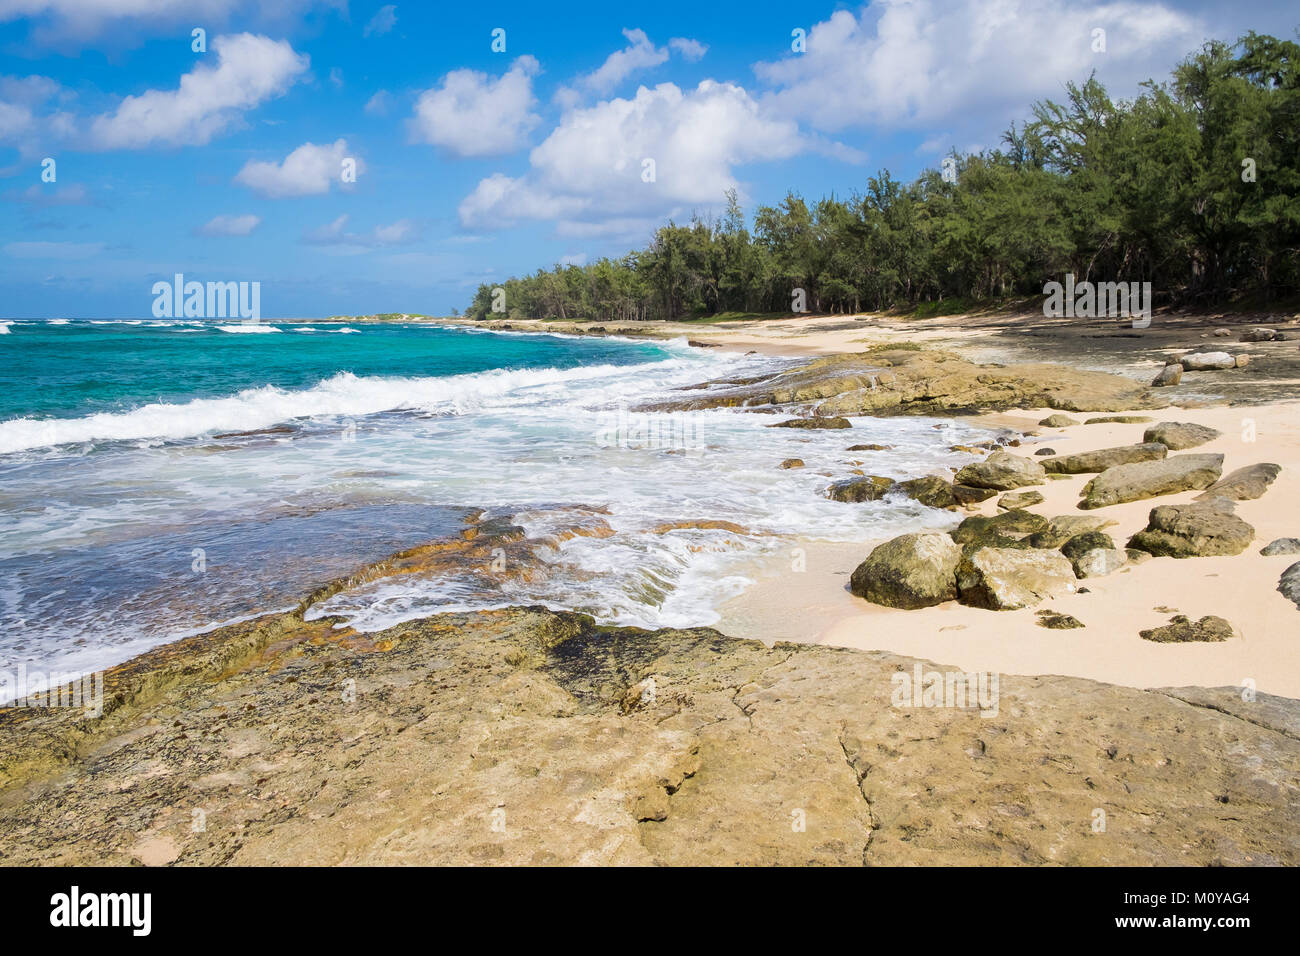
[[849, 532, 962, 609]]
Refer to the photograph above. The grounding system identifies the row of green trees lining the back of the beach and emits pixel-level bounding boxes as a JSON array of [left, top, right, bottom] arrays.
[[467, 33, 1300, 321]]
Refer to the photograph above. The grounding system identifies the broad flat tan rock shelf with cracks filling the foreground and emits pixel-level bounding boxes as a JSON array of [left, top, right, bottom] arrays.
[[0, 607, 1300, 866]]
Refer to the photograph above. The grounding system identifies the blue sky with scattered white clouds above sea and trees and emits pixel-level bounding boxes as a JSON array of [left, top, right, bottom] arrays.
[[0, 0, 1300, 319]]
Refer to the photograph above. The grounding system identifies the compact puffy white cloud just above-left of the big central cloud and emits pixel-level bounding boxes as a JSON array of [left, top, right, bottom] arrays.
[[410, 56, 541, 156]]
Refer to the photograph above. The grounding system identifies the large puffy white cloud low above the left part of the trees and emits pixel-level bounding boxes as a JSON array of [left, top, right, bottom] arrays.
[[459, 79, 806, 237]]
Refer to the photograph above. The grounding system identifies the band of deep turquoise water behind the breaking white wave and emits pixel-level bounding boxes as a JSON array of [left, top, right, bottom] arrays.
[[0, 320, 666, 421]]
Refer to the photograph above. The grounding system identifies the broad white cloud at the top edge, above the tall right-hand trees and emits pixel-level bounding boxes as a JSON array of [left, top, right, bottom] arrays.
[[754, 0, 1204, 131]]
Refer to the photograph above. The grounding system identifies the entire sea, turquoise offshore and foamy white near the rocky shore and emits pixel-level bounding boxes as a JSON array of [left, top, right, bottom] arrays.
[[0, 320, 988, 674]]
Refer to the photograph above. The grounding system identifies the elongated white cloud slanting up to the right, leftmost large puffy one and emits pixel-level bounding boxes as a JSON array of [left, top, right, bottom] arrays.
[[91, 34, 309, 150]]
